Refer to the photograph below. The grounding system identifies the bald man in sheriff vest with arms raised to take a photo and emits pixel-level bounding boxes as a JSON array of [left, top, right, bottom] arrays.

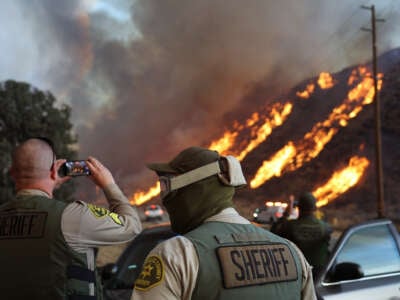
[[0, 138, 141, 300]]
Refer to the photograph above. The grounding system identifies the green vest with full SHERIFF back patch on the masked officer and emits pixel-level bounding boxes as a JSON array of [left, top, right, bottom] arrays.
[[185, 222, 302, 300]]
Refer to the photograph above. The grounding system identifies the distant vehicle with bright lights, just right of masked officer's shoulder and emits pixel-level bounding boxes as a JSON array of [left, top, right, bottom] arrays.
[[253, 201, 299, 224]]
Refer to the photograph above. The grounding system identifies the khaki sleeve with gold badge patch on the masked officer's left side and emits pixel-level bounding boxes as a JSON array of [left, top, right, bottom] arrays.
[[131, 236, 199, 300]]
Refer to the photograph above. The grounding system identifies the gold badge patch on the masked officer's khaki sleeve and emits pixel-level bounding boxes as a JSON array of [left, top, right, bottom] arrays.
[[135, 255, 164, 291]]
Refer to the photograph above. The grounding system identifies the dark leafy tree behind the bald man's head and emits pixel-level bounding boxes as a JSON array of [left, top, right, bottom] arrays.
[[0, 80, 77, 203]]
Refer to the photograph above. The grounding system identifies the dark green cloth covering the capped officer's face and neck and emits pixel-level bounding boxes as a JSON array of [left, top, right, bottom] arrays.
[[163, 175, 235, 234]]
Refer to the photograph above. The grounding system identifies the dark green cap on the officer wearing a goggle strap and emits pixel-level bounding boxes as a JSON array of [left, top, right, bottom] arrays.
[[146, 147, 220, 174]]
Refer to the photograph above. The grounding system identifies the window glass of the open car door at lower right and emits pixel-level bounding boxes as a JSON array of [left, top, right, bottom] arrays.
[[336, 225, 400, 277]]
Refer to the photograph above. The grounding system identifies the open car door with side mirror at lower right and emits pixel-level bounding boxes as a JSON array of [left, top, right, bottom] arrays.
[[315, 220, 400, 300]]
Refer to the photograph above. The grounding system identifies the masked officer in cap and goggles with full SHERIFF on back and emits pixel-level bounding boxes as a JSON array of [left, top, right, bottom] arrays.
[[131, 147, 316, 300]]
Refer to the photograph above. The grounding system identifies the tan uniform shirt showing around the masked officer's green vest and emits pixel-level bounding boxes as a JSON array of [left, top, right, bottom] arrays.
[[131, 208, 317, 300]]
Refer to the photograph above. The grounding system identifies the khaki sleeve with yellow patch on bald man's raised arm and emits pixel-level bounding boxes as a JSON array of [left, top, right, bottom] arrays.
[[61, 184, 142, 252]]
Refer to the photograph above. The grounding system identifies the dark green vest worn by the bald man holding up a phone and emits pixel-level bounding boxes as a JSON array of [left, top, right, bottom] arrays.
[[0, 196, 102, 300]]
